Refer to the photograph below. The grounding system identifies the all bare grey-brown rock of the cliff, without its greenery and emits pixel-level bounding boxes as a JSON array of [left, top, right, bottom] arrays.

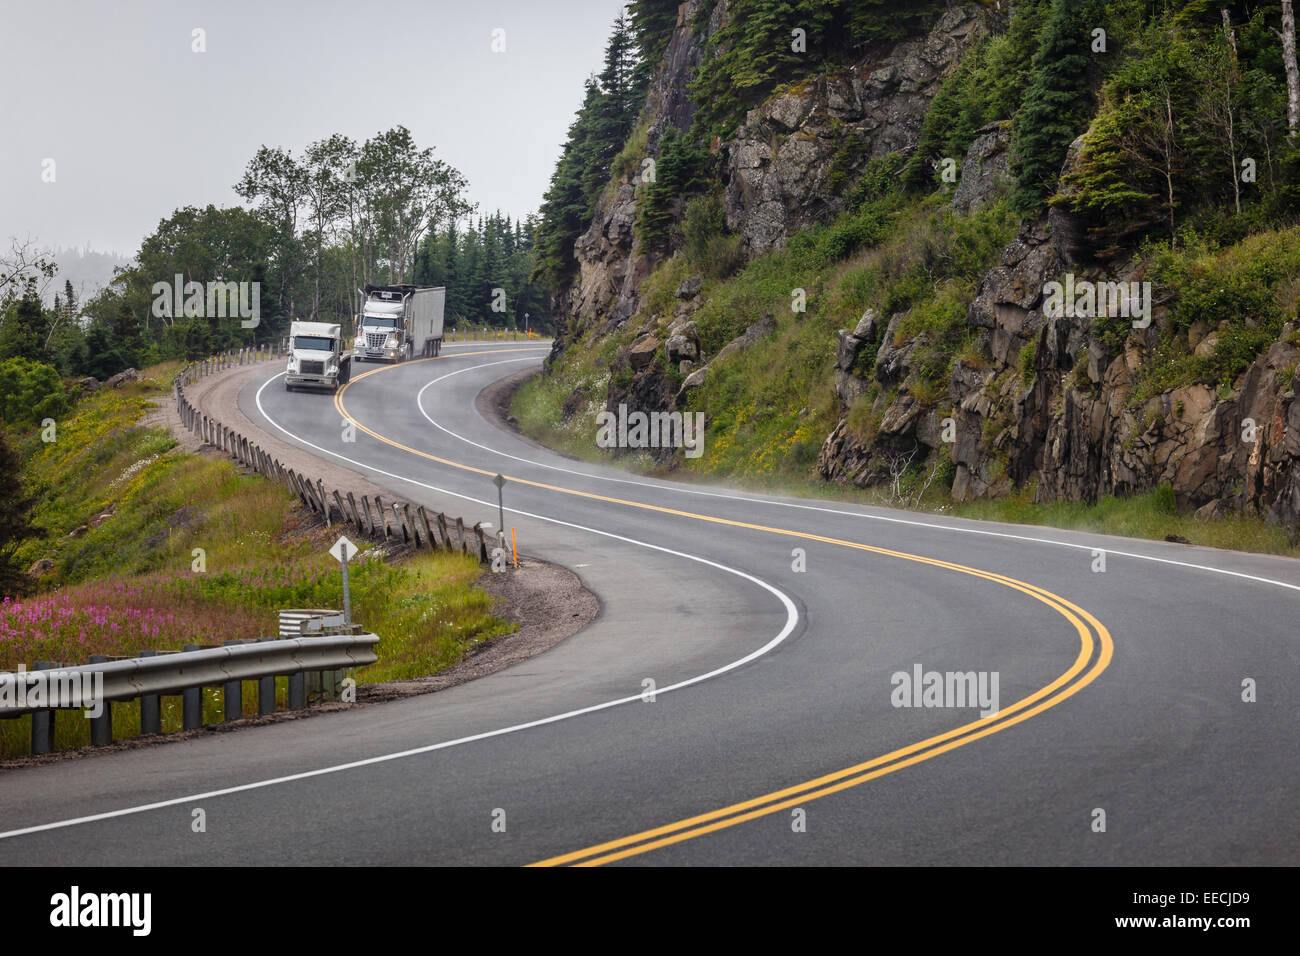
[[553, 0, 1300, 528]]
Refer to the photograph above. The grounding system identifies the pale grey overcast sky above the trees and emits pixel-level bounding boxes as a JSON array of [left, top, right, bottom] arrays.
[[0, 0, 624, 255]]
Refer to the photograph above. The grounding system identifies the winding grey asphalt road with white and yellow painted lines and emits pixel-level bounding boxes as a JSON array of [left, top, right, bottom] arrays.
[[0, 343, 1300, 865]]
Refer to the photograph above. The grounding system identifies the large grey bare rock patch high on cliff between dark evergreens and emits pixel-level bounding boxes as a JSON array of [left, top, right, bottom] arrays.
[[723, 5, 993, 256]]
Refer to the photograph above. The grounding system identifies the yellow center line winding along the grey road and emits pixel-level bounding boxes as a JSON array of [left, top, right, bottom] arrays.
[[334, 349, 1114, 866]]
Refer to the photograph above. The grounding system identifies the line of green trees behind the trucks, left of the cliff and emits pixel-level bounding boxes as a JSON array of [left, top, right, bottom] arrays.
[[0, 126, 550, 392]]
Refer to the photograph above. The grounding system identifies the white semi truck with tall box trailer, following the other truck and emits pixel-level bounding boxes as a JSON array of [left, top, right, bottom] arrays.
[[352, 285, 447, 363]]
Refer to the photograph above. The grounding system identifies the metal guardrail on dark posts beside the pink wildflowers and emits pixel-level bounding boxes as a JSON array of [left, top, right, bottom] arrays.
[[0, 627, 380, 753]]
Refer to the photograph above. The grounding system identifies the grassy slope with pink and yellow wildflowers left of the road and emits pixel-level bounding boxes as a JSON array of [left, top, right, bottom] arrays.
[[0, 367, 512, 756]]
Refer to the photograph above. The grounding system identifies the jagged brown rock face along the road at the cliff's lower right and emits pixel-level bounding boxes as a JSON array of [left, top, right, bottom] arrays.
[[818, 124, 1300, 528]]
